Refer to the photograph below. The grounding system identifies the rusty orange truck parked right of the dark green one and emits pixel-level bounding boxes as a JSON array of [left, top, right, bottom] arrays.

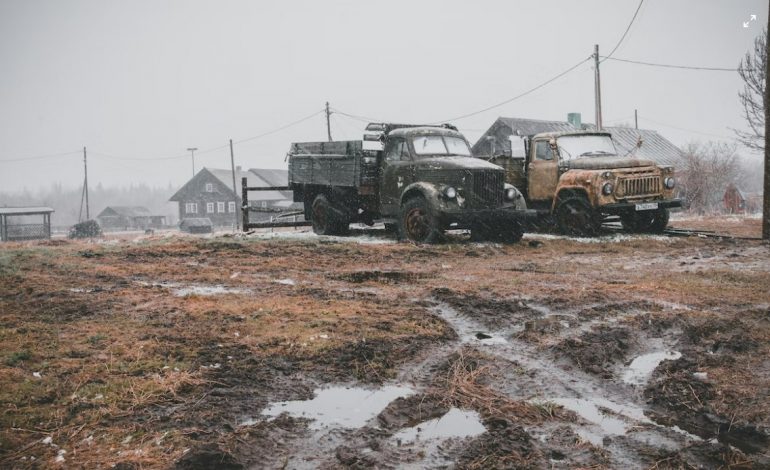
[[509, 131, 681, 235]]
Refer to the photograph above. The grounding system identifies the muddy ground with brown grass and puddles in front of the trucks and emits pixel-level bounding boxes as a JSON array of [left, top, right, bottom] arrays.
[[0, 219, 770, 469]]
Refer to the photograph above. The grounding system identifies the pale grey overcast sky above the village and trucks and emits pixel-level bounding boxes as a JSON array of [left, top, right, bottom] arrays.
[[0, 0, 767, 192]]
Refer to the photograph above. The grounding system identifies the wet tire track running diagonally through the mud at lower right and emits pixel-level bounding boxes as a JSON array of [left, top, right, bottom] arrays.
[[420, 303, 702, 467]]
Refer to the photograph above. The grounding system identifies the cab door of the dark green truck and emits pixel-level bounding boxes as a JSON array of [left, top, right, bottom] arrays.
[[380, 137, 412, 216]]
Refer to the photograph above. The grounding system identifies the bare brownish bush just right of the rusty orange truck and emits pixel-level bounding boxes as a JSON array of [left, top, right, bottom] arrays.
[[678, 142, 740, 213]]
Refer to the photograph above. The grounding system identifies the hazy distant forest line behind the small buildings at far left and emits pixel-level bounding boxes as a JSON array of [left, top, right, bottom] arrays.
[[0, 183, 179, 229]]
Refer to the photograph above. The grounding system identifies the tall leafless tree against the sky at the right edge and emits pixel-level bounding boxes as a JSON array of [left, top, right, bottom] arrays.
[[734, 29, 767, 150]]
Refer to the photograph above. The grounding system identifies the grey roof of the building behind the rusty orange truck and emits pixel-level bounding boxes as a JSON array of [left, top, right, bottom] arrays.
[[472, 117, 682, 165]]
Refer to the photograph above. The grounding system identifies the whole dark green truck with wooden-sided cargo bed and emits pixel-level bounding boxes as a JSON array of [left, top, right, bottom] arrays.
[[288, 124, 535, 243]]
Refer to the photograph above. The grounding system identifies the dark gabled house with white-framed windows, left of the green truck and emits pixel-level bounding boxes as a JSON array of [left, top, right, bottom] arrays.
[[169, 167, 292, 227]]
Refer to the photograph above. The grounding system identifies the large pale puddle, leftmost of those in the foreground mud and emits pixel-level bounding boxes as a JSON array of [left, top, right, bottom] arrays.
[[260, 385, 414, 430]]
